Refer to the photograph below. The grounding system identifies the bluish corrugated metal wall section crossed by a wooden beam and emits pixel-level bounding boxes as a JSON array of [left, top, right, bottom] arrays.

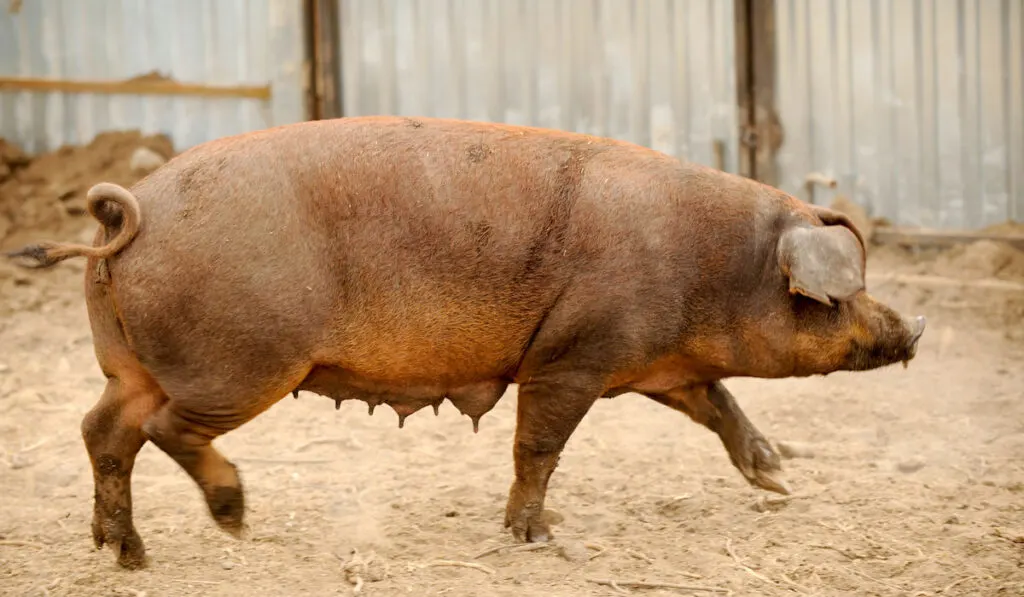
[[0, 0, 306, 152]]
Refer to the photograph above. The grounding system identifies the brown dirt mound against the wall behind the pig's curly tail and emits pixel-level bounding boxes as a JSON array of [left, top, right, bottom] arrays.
[[0, 130, 174, 246]]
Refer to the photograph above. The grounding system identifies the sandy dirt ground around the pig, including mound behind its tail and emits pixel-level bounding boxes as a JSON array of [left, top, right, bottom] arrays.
[[0, 135, 1024, 597]]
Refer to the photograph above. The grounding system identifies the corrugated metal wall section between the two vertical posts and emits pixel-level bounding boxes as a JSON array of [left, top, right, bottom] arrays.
[[340, 0, 737, 171]]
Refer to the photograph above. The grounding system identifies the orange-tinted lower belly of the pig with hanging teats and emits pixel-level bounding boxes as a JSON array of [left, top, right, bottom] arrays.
[[297, 302, 538, 428]]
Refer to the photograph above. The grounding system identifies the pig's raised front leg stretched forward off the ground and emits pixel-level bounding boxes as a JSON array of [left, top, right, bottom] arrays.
[[648, 382, 790, 496]]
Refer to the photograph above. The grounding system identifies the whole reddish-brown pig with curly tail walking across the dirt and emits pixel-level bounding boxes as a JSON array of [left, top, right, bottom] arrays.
[[9, 117, 925, 568]]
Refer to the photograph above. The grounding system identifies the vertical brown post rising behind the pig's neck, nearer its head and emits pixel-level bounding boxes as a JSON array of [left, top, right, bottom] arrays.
[[733, 0, 782, 186]]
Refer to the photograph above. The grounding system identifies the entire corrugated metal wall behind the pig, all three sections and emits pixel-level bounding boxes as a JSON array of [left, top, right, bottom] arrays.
[[8, 0, 1024, 228]]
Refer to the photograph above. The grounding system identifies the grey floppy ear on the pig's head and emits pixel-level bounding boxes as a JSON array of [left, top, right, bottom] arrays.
[[778, 225, 864, 305]]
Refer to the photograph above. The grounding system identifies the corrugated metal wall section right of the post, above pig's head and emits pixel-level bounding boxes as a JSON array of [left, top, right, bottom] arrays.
[[775, 0, 1024, 228]]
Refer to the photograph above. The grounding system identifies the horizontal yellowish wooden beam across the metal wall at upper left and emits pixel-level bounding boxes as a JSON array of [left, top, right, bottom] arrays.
[[0, 77, 270, 99]]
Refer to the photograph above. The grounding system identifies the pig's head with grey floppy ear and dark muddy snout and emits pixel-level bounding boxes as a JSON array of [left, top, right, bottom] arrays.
[[777, 206, 925, 375]]
